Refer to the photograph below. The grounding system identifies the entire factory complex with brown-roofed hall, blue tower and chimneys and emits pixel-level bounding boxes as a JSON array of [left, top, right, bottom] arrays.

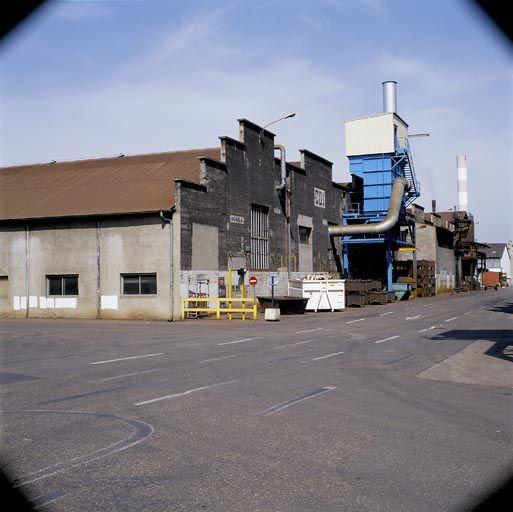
[[0, 81, 496, 320]]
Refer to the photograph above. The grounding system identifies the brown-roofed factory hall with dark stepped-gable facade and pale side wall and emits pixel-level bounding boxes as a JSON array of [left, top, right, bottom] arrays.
[[0, 119, 345, 319]]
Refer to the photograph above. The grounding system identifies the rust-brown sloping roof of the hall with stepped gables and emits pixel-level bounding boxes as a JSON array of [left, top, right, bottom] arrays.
[[0, 148, 220, 220]]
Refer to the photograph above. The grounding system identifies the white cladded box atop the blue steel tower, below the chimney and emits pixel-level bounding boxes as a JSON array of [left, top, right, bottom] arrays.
[[345, 114, 395, 156]]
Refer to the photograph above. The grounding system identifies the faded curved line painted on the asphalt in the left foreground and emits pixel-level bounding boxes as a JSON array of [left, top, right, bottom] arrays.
[[0, 409, 154, 487]]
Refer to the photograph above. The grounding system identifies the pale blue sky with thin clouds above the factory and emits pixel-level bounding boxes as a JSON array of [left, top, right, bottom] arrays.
[[0, 0, 513, 241]]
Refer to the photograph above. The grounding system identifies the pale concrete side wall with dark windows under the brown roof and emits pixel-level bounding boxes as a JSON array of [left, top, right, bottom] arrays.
[[0, 215, 170, 319]]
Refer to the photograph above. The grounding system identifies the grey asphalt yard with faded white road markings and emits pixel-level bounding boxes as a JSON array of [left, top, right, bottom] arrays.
[[0, 289, 513, 512]]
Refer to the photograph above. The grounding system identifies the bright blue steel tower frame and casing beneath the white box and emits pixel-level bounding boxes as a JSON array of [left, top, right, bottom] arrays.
[[342, 138, 420, 291]]
